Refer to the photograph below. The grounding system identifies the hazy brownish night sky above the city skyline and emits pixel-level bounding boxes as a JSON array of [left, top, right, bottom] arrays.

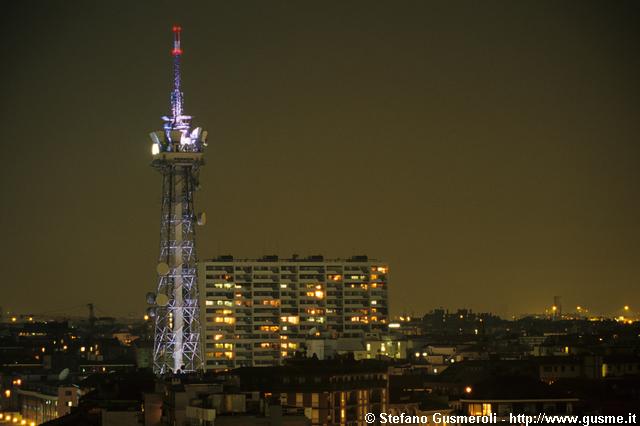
[[0, 0, 640, 317]]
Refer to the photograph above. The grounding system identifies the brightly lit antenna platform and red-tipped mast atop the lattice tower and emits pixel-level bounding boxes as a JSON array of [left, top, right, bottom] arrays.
[[150, 25, 207, 156]]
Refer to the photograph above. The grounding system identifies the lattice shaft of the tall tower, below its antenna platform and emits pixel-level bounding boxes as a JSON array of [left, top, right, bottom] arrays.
[[153, 153, 202, 374]]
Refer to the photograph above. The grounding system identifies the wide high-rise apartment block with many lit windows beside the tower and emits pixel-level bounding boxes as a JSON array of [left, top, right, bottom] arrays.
[[198, 256, 389, 369]]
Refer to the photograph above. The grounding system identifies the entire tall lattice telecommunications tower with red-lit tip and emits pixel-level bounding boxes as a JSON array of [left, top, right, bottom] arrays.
[[147, 26, 207, 375]]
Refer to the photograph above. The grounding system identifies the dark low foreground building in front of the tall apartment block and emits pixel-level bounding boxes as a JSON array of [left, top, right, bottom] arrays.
[[145, 359, 388, 426]]
